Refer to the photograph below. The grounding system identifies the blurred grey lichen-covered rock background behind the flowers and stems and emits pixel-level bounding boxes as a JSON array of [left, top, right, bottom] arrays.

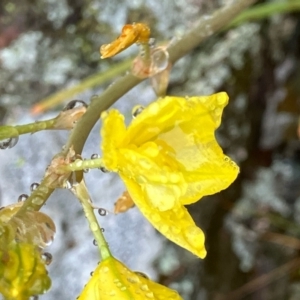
[[0, 0, 300, 300]]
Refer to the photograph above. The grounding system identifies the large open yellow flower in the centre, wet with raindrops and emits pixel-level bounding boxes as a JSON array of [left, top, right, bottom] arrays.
[[101, 92, 239, 258]]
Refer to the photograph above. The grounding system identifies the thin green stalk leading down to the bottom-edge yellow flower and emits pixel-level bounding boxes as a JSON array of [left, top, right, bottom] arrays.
[[71, 180, 112, 260]]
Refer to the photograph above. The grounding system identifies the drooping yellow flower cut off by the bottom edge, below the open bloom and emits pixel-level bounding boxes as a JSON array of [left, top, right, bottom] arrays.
[[78, 257, 182, 300]]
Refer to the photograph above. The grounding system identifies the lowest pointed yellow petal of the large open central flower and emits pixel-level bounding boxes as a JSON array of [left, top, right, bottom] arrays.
[[121, 175, 206, 258]]
